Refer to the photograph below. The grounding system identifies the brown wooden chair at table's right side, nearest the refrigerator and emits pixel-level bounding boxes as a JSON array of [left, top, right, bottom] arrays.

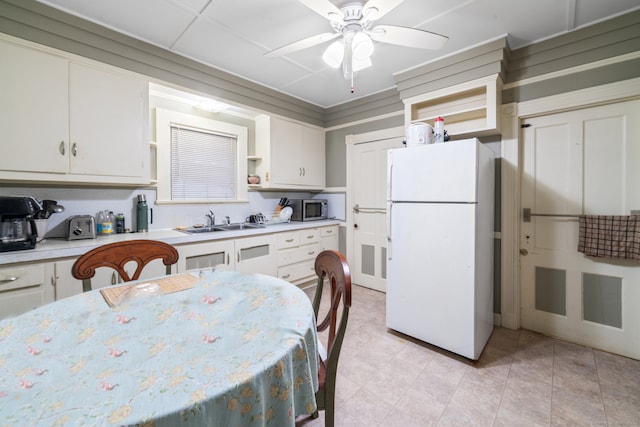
[[312, 251, 351, 427]]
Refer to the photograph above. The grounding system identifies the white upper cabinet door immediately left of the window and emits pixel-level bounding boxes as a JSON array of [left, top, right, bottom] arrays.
[[69, 64, 149, 182]]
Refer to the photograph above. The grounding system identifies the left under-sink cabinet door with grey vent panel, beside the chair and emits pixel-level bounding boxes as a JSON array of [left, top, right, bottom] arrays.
[[178, 240, 235, 273]]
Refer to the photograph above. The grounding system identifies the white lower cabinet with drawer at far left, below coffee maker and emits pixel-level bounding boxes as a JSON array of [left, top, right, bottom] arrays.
[[0, 263, 55, 319]]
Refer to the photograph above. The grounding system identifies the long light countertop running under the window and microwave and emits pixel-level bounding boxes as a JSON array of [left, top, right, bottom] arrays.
[[0, 220, 340, 266]]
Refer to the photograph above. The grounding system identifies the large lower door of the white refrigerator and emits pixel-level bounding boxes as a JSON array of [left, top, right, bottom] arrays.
[[387, 203, 479, 359]]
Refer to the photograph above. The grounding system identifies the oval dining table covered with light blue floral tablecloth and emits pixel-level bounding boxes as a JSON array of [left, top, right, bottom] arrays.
[[0, 271, 318, 427]]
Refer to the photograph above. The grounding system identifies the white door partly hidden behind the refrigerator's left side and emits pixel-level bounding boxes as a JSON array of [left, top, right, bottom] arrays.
[[350, 138, 402, 292]]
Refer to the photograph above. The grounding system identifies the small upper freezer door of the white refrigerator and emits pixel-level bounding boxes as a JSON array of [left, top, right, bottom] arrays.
[[387, 138, 479, 203]]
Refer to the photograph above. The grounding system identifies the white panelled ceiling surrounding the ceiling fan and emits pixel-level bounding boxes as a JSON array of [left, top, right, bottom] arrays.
[[33, 0, 640, 107]]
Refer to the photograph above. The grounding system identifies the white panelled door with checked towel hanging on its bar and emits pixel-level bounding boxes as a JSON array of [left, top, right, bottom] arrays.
[[520, 101, 640, 359]]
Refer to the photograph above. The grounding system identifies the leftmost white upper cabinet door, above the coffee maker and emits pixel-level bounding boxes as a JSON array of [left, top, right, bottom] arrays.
[[0, 40, 69, 173]]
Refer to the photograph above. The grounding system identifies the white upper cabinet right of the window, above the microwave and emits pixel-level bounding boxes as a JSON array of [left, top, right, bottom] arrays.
[[255, 116, 325, 190]]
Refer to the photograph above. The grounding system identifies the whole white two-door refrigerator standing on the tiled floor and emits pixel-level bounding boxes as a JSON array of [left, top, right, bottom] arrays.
[[387, 138, 494, 360]]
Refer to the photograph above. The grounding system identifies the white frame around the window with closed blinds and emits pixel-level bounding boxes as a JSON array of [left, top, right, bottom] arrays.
[[155, 108, 248, 204]]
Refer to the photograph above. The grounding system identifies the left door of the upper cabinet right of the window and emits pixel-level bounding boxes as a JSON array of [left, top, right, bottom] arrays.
[[270, 119, 302, 185]]
